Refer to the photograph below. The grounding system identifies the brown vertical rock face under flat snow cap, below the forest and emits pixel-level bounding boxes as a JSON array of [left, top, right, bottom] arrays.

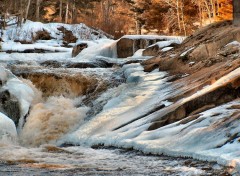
[[117, 37, 161, 58]]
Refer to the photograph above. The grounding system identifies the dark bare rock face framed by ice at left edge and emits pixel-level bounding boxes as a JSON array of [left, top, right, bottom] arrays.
[[0, 90, 21, 126]]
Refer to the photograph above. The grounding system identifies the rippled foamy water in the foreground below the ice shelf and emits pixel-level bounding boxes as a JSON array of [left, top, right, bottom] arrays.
[[0, 146, 228, 176]]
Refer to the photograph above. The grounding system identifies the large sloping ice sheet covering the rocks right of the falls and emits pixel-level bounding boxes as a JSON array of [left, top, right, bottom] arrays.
[[59, 64, 240, 173]]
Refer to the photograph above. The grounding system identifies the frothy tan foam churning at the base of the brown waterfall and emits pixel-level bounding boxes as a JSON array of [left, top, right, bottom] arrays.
[[20, 97, 89, 146]]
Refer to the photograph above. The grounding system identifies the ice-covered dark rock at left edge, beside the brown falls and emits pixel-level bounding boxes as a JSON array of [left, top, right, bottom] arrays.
[[0, 67, 34, 128]]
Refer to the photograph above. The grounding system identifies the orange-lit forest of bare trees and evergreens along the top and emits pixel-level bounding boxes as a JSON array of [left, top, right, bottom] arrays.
[[0, 0, 232, 38]]
